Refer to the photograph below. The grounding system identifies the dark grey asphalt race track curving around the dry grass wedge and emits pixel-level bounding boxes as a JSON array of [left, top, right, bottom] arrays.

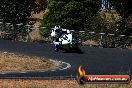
[[0, 39, 132, 77]]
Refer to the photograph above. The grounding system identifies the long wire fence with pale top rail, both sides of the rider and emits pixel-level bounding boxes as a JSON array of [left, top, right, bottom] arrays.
[[0, 22, 132, 48]]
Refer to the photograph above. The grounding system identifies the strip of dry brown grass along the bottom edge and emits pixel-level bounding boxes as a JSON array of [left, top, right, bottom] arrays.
[[0, 79, 132, 88]]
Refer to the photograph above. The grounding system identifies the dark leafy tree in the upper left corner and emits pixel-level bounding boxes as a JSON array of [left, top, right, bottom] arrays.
[[0, 0, 47, 24]]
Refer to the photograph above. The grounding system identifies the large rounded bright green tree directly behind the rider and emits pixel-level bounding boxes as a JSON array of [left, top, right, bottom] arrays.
[[41, 0, 99, 30]]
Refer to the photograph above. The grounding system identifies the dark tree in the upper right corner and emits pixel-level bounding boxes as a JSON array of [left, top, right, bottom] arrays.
[[109, 0, 132, 35]]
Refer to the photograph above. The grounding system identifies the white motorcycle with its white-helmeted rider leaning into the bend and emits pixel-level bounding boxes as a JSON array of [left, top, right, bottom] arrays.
[[51, 26, 78, 52]]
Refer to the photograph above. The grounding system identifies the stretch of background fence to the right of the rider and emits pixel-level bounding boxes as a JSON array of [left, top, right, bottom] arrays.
[[79, 32, 132, 48]]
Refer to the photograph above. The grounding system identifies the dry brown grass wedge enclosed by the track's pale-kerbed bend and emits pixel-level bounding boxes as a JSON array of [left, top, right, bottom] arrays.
[[0, 52, 55, 72]]
